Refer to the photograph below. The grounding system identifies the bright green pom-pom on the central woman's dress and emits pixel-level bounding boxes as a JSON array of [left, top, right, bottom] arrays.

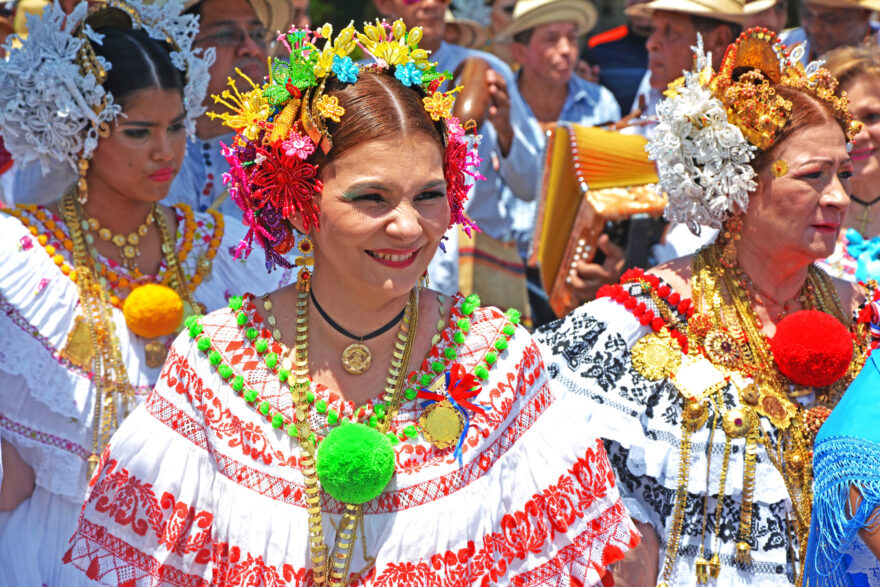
[[317, 423, 394, 504]]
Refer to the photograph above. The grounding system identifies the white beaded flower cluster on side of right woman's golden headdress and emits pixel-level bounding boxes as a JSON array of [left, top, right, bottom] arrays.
[[646, 34, 757, 234]]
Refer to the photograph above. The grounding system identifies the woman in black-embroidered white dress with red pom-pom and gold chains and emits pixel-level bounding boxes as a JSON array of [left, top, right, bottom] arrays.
[[539, 29, 872, 586]]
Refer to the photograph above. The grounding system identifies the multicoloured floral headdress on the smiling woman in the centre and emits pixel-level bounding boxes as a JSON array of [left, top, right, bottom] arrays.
[[209, 20, 480, 270]]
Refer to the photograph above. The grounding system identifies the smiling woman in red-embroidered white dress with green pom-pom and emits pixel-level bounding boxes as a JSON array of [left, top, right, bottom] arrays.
[[66, 21, 638, 585]]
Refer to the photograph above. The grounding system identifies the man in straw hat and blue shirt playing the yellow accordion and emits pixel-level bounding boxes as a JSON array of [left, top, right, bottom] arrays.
[[502, 0, 623, 324]]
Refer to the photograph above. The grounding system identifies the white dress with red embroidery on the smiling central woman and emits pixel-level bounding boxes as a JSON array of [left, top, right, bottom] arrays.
[[67, 296, 638, 586]]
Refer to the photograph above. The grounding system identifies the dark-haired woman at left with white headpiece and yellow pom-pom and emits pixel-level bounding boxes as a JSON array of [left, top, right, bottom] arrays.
[[0, 2, 285, 586]]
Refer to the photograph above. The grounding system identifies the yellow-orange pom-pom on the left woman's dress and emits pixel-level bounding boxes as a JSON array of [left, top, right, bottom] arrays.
[[122, 283, 183, 338]]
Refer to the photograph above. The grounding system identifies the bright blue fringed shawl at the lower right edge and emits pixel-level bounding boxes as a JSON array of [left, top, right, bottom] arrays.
[[804, 352, 880, 587]]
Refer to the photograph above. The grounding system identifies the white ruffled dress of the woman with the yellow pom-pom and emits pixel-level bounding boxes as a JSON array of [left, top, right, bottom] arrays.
[[0, 207, 289, 587]]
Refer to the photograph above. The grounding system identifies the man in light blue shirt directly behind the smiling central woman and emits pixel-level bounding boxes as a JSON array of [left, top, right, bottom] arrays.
[[374, 0, 541, 293]]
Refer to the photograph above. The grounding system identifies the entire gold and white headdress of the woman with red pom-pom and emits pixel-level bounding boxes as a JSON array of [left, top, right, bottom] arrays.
[[646, 28, 860, 234]]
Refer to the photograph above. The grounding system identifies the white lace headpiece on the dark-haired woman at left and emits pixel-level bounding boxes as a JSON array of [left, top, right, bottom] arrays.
[[0, 0, 214, 174]]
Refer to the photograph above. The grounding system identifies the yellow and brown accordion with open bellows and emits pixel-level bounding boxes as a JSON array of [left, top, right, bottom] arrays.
[[530, 123, 666, 317]]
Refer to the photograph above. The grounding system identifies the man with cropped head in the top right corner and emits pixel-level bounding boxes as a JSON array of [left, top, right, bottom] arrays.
[[780, 0, 880, 64]]
